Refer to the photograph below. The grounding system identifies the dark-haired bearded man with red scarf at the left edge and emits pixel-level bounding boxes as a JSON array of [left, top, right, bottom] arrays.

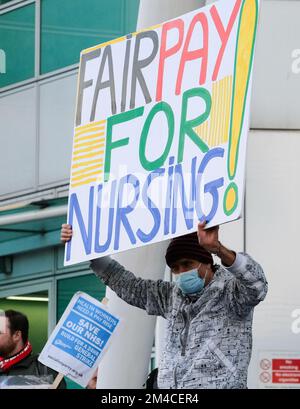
[[0, 310, 66, 389]]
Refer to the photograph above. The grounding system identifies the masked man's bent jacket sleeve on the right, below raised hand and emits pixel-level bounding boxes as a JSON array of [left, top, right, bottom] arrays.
[[225, 253, 268, 318]]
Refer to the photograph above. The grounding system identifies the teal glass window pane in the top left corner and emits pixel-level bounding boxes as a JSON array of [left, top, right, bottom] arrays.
[[0, 4, 35, 88]]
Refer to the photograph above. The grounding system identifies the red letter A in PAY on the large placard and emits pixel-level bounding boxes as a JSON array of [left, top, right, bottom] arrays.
[[176, 13, 208, 95]]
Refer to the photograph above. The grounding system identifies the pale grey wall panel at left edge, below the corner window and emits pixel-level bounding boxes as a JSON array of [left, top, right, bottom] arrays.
[[0, 87, 36, 197]]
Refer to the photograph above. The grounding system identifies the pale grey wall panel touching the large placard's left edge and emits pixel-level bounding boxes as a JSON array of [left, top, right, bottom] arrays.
[[39, 74, 77, 185]]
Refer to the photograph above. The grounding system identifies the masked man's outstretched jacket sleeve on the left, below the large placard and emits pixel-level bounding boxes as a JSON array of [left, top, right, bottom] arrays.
[[91, 257, 173, 317]]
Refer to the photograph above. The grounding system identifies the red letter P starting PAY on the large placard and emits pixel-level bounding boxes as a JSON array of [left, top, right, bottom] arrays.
[[156, 19, 184, 101]]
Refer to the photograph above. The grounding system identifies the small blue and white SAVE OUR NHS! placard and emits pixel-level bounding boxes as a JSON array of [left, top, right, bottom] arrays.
[[39, 292, 120, 387]]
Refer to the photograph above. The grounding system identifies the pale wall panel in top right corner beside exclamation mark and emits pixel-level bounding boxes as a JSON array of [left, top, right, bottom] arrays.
[[251, 0, 300, 129]]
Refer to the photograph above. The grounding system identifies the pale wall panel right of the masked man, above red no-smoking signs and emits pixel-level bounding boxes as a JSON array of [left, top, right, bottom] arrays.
[[246, 131, 300, 388]]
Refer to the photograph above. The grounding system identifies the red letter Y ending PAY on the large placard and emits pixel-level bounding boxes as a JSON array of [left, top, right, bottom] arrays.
[[210, 0, 241, 81]]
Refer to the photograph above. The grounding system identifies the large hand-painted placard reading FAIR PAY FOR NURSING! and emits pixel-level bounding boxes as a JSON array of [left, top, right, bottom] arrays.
[[65, 0, 259, 265]]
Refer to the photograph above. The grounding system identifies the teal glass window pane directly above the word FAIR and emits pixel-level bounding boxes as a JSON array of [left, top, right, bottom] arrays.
[[41, 0, 139, 74]]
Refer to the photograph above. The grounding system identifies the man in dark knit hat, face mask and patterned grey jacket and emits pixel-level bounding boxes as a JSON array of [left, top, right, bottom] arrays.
[[61, 221, 268, 389]]
